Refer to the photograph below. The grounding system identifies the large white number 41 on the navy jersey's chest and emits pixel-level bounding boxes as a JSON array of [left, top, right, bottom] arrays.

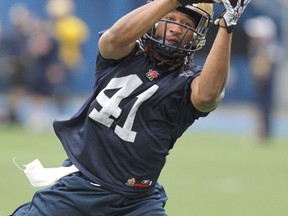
[[89, 74, 159, 142]]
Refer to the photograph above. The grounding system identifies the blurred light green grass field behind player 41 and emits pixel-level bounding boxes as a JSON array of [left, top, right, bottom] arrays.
[[0, 125, 288, 216]]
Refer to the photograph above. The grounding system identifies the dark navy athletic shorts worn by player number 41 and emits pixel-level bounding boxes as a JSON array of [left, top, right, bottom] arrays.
[[12, 172, 167, 216]]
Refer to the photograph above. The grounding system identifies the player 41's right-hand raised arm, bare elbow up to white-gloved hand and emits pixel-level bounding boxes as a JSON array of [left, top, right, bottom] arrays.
[[191, 0, 250, 112]]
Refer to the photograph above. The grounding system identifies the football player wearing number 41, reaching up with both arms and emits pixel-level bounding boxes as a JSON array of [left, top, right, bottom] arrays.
[[13, 0, 249, 216]]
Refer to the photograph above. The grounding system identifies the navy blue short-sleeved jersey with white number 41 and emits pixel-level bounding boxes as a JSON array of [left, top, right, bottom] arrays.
[[54, 41, 207, 195]]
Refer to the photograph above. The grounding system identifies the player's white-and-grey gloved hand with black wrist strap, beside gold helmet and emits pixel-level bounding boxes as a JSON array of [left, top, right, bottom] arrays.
[[215, 0, 251, 33]]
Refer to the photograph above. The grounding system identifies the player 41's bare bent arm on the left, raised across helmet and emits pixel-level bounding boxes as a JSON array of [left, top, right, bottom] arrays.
[[99, 0, 180, 57]]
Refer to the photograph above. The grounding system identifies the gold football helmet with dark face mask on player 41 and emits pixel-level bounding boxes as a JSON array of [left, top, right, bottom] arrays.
[[144, 1, 213, 58]]
